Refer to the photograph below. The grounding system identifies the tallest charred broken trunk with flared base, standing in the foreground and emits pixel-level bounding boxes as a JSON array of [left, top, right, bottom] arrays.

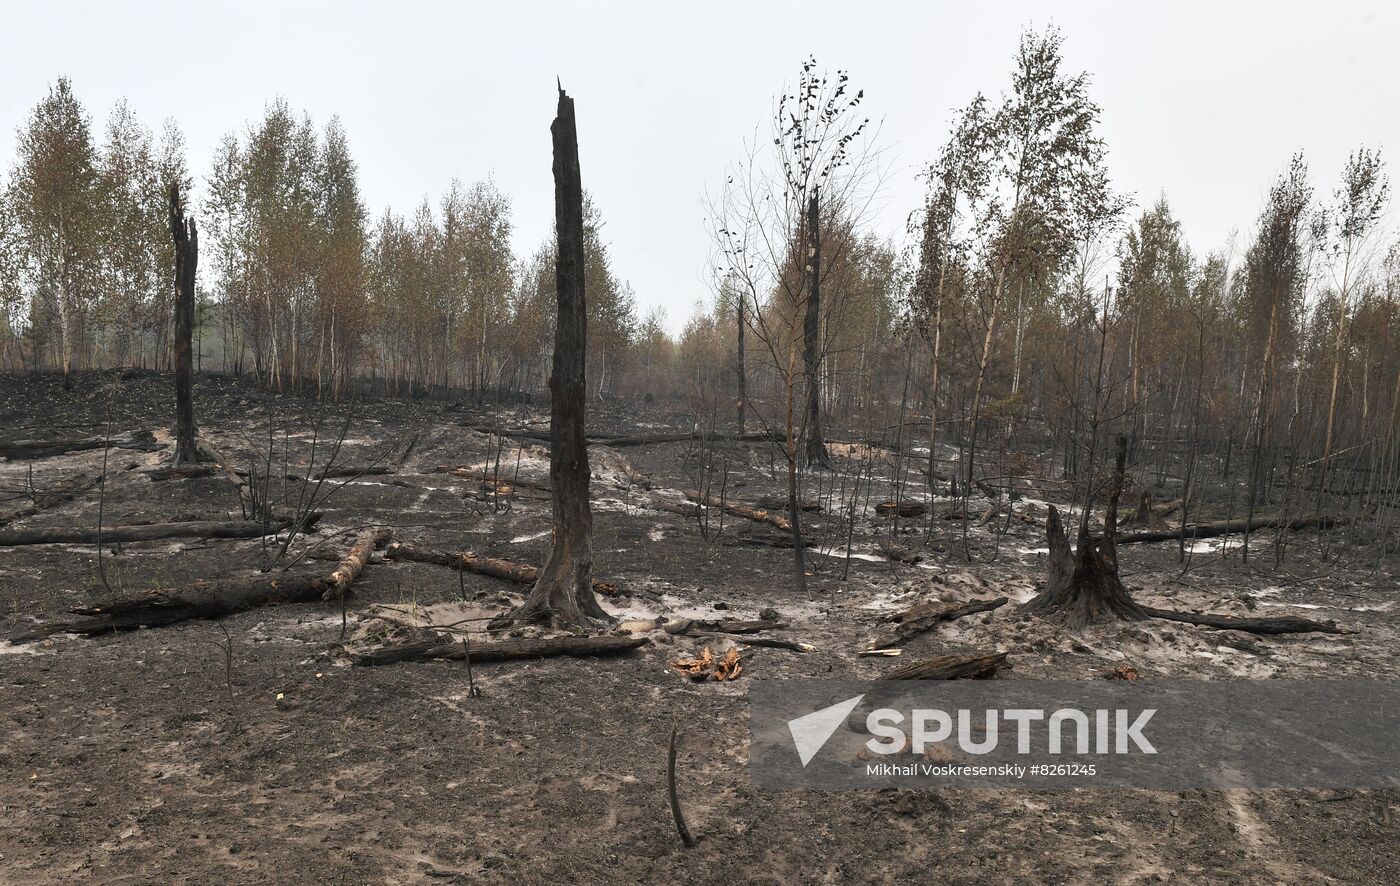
[[504, 87, 612, 628]]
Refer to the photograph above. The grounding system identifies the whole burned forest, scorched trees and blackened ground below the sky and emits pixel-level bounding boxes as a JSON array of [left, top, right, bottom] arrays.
[[0, 10, 1400, 885]]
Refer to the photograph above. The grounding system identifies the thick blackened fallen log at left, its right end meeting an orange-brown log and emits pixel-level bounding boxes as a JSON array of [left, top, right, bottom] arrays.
[[10, 574, 326, 642]]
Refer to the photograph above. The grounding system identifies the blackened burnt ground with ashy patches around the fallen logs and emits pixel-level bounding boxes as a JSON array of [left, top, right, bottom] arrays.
[[0, 372, 1400, 885]]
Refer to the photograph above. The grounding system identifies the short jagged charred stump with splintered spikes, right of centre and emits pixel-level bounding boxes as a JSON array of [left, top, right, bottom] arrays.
[[1021, 437, 1151, 630]]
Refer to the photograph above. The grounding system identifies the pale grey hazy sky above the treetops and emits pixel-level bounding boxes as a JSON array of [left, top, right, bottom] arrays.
[[0, 0, 1400, 329]]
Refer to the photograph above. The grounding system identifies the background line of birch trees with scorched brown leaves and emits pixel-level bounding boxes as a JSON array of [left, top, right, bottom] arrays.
[[0, 28, 1400, 565]]
